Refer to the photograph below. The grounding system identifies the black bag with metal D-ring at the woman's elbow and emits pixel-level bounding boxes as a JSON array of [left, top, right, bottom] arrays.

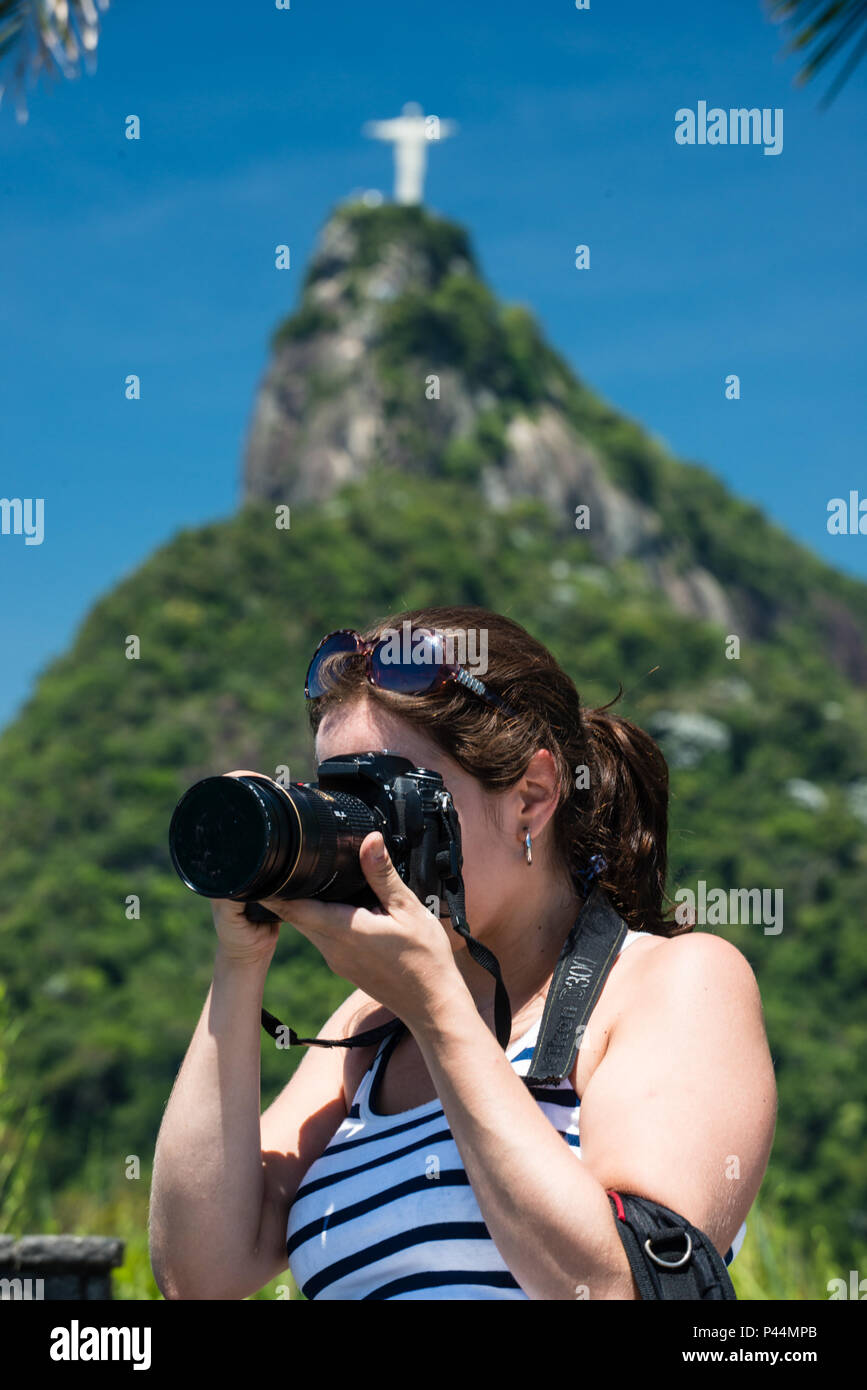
[[607, 1190, 738, 1301]]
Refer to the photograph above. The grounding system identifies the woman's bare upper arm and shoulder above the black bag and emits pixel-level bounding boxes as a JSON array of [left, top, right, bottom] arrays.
[[572, 931, 777, 1255]]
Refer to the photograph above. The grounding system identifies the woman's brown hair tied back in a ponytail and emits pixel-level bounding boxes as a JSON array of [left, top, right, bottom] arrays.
[[310, 606, 689, 937]]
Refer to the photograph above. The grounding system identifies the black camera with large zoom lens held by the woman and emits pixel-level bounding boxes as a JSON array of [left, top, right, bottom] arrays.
[[170, 752, 461, 922]]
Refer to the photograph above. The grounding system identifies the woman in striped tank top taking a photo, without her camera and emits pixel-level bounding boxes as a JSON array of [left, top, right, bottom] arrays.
[[151, 607, 775, 1300]]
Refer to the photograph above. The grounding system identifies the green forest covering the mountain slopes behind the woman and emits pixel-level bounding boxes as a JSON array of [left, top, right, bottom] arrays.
[[0, 207, 867, 1297]]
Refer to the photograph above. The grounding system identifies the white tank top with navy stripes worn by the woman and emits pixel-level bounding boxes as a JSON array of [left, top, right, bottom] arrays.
[[286, 931, 746, 1300]]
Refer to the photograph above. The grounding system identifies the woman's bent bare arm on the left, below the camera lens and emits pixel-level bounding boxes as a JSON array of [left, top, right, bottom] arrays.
[[150, 949, 358, 1298]]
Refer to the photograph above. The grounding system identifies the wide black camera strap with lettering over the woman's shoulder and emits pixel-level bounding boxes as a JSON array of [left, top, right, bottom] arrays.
[[524, 884, 628, 1087]]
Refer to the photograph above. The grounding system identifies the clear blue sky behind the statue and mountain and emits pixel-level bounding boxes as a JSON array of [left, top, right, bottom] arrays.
[[0, 0, 867, 723]]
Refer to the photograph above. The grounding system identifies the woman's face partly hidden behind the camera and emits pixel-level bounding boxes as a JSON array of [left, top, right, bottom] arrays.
[[315, 699, 527, 949]]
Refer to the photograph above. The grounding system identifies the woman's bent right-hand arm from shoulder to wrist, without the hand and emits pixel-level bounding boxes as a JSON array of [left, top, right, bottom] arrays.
[[407, 934, 775, 1300]]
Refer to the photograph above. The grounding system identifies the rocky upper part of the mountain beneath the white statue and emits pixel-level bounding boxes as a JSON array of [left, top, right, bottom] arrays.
[[243, 200, 867, 684]]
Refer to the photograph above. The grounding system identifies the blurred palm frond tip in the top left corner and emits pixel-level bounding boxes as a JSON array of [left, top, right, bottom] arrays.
[[0, 0, 108, 121]]
